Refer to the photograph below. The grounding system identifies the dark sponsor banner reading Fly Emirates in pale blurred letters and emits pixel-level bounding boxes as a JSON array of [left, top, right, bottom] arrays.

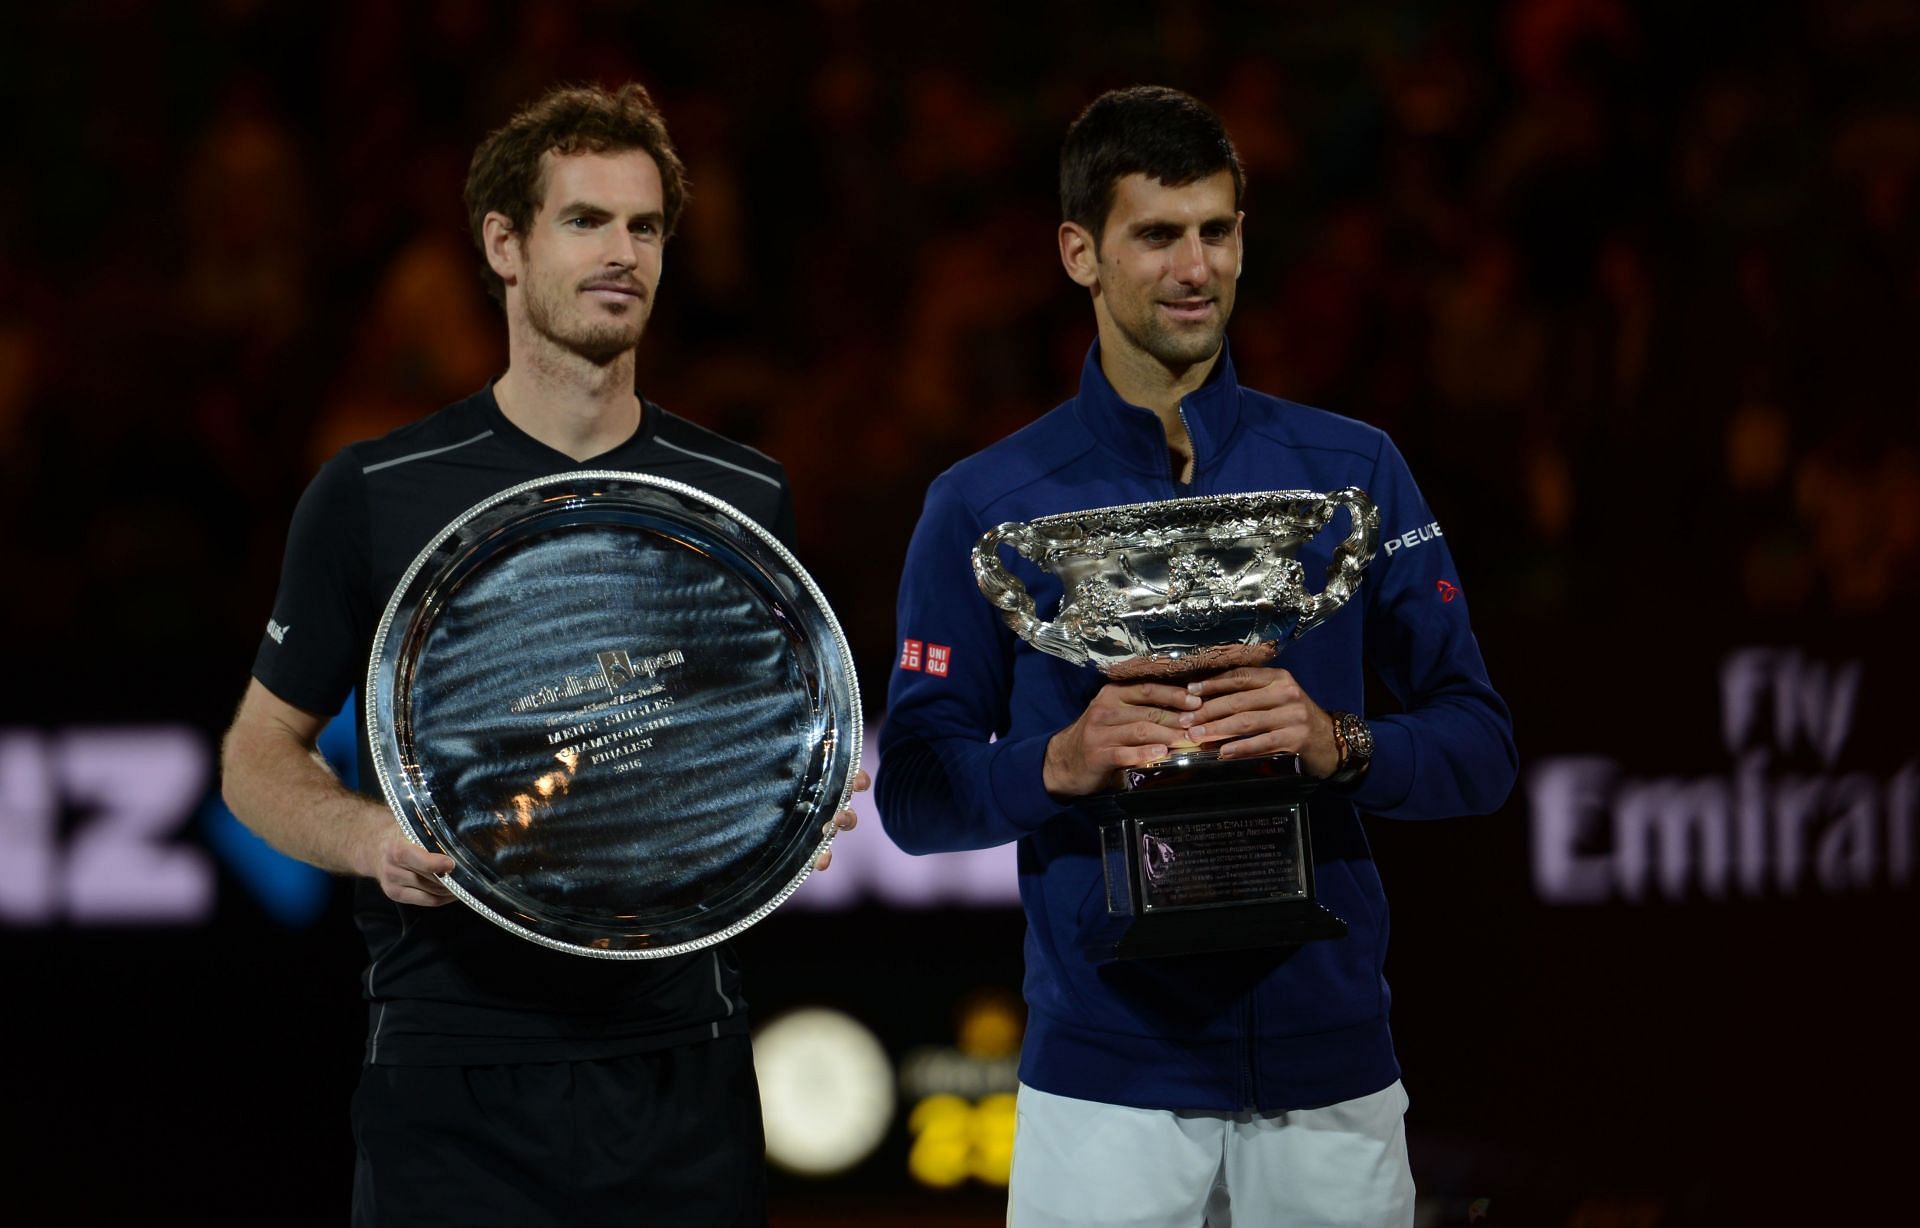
[[1521, 643, 1920, 908]]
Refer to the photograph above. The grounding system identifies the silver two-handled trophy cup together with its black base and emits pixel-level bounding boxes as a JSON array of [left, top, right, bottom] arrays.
[[973, 487, 1380, 959]]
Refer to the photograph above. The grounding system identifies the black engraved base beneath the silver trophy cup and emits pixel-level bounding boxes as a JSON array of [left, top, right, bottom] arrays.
[[1083, 754, 1348, 963]]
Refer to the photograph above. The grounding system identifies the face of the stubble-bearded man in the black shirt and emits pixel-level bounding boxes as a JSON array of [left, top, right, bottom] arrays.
[[518, 150, 666, 363]]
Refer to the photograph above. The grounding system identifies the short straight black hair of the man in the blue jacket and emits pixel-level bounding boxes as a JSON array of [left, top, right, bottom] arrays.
[[1060, 84, 1246, 244]]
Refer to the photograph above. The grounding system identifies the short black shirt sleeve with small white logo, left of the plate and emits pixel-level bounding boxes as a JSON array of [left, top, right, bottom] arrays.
[[253, 453, 372, 716]]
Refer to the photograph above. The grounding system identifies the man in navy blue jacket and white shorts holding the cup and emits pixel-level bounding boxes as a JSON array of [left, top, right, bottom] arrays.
[[877, 86, 1515, 1228]]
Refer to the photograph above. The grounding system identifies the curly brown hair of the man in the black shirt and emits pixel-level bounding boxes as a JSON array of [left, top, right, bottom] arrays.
[[467, 83, 687, 301]]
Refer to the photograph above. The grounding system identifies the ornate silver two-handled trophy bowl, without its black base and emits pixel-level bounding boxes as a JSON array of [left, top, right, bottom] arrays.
[[973, 487, 1380, 681]]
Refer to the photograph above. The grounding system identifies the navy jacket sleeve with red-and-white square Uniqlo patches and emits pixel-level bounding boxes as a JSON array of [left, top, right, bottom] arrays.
[[874, 476, 1064, 854]]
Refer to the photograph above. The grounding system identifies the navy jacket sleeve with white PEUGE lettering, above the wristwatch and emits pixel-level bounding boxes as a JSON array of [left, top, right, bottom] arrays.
[[1352, 437, 1519, 819]]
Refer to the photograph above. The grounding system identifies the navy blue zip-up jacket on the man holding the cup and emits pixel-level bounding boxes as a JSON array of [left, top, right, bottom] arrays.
[[876, 343, 1515, 1111]]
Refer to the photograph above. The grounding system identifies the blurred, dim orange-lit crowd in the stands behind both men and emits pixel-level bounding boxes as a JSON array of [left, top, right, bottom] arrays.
[[0, 0, 1920, 702]]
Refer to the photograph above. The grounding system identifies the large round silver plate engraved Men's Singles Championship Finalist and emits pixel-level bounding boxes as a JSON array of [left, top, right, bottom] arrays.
[[367, 470, 860, 959]]
